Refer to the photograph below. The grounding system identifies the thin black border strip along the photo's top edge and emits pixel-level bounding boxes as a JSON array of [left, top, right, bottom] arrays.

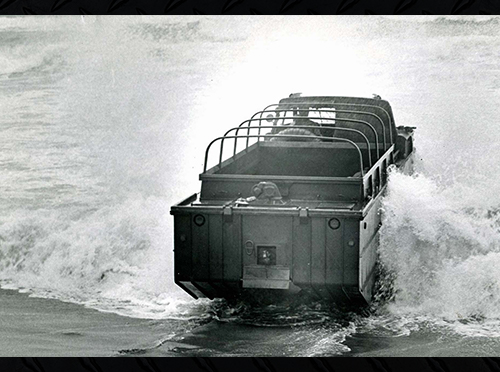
[[0, 0, 500, 15]]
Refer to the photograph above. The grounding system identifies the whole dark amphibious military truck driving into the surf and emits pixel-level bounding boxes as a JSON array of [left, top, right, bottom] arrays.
[[171, 94, 414, 304]]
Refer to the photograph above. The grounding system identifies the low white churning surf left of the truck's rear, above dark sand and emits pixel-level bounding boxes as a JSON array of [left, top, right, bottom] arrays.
[[0, 198, 207, 318]]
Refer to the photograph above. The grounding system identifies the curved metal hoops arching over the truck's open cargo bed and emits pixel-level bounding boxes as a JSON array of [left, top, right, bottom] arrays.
[[203, 101, 395, 200]]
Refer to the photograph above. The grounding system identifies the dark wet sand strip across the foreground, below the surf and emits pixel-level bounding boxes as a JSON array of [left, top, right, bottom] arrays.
[[0, 290, 500, 357]]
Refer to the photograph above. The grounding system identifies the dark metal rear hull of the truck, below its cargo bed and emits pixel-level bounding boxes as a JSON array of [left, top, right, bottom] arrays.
[[172, 151, 418, 304]]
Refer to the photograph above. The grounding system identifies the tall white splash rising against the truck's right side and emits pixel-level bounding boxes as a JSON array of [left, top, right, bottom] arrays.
[[380, 167, 500, 320]]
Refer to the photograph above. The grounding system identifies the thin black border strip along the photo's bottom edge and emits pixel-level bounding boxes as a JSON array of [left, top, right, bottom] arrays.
[[0, 357, 500, 372]]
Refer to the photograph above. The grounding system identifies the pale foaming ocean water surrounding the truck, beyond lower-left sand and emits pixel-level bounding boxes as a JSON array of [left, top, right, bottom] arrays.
[[0, 16, 500, 356]]
